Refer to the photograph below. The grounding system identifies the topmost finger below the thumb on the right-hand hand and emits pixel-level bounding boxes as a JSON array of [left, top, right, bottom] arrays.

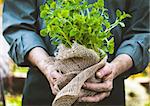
[[83, 81, 113, 92]]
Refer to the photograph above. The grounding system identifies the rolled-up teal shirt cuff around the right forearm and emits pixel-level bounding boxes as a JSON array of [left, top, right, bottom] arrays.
[[116, 40, 144, 78]]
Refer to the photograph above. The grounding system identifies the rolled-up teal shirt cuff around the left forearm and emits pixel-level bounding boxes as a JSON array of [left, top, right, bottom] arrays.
[[8, 30, 47, 66]]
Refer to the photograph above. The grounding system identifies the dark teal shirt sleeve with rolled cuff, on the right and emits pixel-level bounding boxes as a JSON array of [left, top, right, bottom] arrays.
[[116, 0, 150, 77]]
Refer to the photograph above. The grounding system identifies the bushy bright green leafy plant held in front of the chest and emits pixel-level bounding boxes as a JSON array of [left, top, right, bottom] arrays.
[[40, 0, 130, 55]]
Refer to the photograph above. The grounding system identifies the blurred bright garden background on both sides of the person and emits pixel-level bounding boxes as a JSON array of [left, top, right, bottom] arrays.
[[0, 0, 150, 106]]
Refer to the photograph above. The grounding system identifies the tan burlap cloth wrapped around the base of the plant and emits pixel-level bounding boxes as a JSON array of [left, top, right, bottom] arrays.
[[52, 42, 107, 106]]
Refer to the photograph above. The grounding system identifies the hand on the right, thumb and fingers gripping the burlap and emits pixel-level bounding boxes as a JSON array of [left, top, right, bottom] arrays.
[[78, 63, 116, 102]]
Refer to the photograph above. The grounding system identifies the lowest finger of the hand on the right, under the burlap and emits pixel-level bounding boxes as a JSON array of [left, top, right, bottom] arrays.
[[78, 92, 110, 102]]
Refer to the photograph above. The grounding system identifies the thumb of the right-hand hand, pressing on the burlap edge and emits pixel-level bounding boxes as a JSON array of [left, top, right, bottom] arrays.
[[96, 63, 112, 79]]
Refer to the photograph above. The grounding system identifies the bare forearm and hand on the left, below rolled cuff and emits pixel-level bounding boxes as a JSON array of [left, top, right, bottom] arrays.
[[26, 47, 62, 95]]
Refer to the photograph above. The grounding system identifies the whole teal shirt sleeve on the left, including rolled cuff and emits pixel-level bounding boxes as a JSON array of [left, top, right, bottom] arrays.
[[3, 0, 46, 65]]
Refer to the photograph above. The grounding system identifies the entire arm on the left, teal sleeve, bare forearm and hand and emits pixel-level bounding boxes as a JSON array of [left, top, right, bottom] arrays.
[[3, 0, 60, 93]]
